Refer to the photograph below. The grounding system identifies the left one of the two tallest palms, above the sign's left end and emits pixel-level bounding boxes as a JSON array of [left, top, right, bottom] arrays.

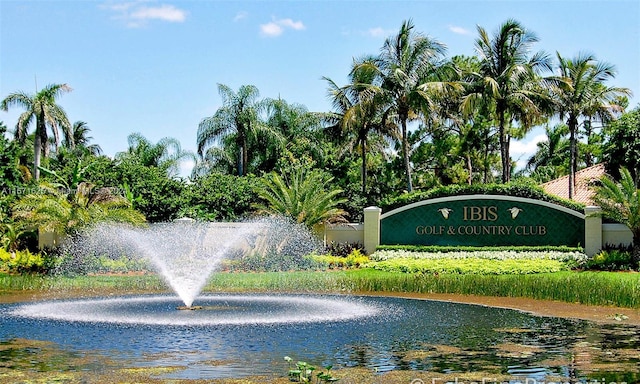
[[365, 20, 452, 192]]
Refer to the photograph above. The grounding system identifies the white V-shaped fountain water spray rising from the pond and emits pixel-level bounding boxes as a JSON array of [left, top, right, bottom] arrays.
[[61, 218, 319, 309]]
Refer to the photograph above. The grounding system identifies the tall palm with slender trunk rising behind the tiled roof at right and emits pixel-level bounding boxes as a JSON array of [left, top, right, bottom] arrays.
[[553, 53, 631, 199]]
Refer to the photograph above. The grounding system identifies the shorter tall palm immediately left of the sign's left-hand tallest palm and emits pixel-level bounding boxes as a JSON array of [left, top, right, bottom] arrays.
[[323, 60, 397, 196]]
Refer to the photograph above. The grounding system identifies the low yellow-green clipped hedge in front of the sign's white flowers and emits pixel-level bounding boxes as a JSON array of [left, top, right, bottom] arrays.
[[365, 257, 569, 275]]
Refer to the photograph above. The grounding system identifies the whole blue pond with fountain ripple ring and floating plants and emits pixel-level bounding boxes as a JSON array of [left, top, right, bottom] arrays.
[[0, 294, 640, 383]]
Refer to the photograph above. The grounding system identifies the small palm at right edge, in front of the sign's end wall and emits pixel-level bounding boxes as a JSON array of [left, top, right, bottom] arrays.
[[593, 167, 640, 266]]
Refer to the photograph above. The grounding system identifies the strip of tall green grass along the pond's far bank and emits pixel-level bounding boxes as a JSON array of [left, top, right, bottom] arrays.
[[0, 269, 640, 308]]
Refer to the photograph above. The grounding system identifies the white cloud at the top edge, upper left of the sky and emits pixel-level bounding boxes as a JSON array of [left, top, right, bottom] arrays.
[[102, 1, 187, 28]]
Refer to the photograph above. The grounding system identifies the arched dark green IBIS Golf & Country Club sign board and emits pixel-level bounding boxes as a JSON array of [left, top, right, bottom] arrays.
[[380, 195, 585, 247]]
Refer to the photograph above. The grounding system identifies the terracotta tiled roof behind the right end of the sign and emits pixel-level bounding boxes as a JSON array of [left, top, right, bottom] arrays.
[[540, 163, 605, 205]]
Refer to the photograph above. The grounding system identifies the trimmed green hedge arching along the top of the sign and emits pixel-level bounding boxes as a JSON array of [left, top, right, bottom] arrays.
[[380, 182, 584, 212]]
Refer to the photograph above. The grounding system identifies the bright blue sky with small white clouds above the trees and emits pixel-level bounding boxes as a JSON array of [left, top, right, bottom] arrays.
[[0, 0, 640, 175]]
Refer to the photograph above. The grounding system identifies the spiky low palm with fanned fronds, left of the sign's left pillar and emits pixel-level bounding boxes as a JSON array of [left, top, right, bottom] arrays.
[[257, 167, 345, 228]]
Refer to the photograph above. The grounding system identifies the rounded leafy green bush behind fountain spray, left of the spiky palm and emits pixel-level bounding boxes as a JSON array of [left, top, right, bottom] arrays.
[[178, 173, 258, 221]]
